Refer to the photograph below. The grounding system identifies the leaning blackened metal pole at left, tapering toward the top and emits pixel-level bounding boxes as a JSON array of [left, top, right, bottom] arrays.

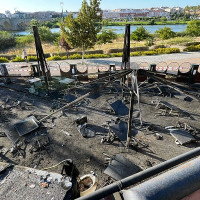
[[33, 26, 49, 91]]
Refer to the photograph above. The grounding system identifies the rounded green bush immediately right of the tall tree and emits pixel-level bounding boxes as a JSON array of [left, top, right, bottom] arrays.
[[97, 30, 117, 44]]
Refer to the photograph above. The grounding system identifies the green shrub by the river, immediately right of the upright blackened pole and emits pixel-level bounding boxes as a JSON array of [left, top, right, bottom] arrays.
[[131, 26, 151, 41]]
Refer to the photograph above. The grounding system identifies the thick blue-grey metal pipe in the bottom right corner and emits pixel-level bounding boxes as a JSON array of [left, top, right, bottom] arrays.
[[123, 157, 200, 200]]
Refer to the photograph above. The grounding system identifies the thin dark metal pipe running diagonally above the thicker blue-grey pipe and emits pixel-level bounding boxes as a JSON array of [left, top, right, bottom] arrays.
[[77, 147, 200, 200]]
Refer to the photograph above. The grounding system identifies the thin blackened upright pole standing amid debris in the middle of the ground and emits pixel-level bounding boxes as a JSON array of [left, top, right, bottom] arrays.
[[126, 91, 134, 148]]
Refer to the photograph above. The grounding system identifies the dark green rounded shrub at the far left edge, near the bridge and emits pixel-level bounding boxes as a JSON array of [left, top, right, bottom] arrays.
[[0, 31, 16, 50]]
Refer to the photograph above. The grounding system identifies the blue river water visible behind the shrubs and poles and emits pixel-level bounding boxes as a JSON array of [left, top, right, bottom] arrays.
[[13, 24, 187, 35]]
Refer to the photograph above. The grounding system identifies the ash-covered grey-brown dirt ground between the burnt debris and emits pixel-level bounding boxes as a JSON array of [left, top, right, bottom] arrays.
[[0, 74, 200, 188]]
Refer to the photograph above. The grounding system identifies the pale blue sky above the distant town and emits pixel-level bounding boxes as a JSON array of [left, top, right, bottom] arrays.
[[0, 0, 200, 13]]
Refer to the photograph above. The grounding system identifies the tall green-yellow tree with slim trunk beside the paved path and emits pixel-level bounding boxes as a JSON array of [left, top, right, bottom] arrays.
[[61, 0, 102, 61]]
